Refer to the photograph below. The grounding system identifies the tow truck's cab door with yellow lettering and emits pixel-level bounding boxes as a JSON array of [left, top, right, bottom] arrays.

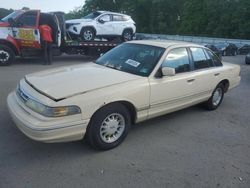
[[13, 11, 41, 49]]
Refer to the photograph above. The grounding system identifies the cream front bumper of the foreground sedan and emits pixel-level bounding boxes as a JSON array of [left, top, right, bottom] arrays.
[[7, 92, 89, 143]]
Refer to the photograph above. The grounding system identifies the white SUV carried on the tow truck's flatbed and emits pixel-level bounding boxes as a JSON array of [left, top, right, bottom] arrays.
[[66, 11, 136, 41]]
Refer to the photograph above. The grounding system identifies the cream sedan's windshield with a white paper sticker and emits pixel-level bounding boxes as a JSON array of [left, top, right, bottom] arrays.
[[96, 43, 165, 77]]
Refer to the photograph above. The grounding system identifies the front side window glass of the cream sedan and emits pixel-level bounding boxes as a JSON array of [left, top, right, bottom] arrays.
[[162, 48, 190, 73]]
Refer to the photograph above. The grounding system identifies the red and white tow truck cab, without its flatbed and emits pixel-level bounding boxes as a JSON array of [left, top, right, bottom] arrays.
[[0, 10, 65, 66]]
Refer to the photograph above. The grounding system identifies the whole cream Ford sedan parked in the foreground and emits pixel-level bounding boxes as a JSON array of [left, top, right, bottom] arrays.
[[7, 41, 240, 150]]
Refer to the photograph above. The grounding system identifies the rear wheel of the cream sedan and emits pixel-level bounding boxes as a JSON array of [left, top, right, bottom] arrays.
[[205, 83, 225, 110]]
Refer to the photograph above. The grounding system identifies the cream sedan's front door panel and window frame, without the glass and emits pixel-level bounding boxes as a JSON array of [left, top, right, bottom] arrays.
[[148, 45, 200, 118]]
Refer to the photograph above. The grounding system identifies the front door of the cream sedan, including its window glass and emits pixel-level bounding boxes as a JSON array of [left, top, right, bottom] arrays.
[[149, 47, 196, 118]]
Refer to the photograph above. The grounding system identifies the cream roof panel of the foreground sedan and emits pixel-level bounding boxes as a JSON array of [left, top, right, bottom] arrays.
[[127, 40, 204, 48]]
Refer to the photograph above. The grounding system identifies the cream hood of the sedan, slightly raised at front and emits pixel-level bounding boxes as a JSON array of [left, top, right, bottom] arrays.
[[25, 63, 141, 100]]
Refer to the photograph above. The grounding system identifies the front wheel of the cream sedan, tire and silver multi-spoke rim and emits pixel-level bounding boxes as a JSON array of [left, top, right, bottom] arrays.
[[86, 103, 131, 150]]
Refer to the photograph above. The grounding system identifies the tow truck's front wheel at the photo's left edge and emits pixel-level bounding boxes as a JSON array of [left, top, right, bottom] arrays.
[[0, 44, 15, 66]]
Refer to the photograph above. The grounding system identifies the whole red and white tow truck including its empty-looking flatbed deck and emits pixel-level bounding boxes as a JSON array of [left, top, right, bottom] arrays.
[[0, 10, 122, 66]]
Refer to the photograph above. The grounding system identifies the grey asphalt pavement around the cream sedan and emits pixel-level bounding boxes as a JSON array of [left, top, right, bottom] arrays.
[[0, 56, 250, 188]]
